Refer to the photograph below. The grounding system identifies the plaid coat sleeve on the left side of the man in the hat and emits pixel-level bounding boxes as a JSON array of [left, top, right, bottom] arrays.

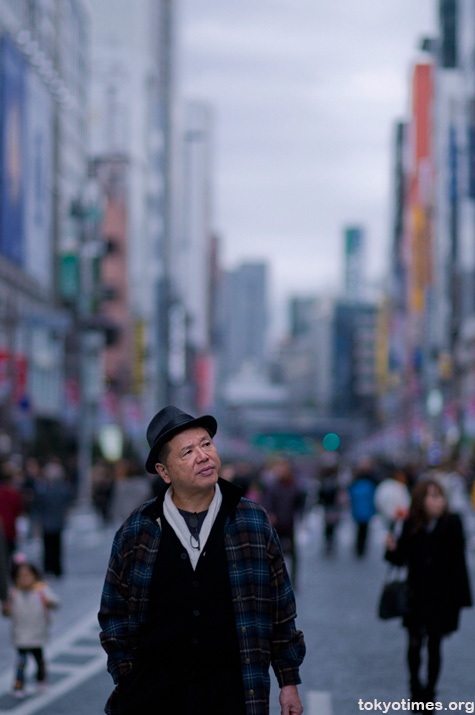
[[98, 530, 133, 683]]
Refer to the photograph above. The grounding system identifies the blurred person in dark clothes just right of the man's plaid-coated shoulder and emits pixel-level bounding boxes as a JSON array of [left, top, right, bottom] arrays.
[[261, 457, 305, 588]]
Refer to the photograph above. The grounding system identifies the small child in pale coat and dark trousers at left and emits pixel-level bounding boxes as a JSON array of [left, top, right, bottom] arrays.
[[3, 561, 59, 697]]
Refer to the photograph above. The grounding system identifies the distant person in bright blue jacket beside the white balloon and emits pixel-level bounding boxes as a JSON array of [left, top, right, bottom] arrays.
[[348, 457, 376, 558]]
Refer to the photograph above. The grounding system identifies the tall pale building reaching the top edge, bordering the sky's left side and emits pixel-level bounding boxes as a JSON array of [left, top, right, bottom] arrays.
[[89, 0, 176, 429]]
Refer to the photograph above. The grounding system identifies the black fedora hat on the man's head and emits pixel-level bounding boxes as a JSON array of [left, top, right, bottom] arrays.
[[145, 405, 218, 474]]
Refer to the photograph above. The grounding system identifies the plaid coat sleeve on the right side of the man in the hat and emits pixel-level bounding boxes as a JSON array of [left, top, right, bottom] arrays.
[[267, 525, 305, 688]]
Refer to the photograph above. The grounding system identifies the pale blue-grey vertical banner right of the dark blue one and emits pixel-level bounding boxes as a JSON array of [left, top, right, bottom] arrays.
[[25, 72, 53, 288]]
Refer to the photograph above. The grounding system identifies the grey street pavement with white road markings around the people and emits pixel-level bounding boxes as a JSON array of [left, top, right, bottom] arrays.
[[0, 504, 475, 715]]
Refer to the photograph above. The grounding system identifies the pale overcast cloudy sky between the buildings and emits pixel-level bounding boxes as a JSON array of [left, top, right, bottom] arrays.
[[180, 0, 437, 330]]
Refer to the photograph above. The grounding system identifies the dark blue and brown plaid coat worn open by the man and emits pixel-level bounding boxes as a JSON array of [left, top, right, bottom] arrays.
[[99, 479, 305, 715]]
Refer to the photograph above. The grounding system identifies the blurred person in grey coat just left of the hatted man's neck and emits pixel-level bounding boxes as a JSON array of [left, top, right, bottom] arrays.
[[111, 459, 152, 527]]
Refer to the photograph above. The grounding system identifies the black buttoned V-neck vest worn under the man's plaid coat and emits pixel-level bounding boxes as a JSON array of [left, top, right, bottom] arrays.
[[141, 504, 239, 672]]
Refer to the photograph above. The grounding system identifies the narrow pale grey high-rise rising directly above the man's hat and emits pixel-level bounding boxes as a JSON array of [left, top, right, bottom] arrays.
[[169, 101, 217, 411]]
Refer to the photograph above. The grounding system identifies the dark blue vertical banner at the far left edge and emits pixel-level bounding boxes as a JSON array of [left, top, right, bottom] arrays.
[[0, 37, 26, 267]]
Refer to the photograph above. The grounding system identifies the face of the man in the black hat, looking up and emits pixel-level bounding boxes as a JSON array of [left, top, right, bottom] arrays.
[[156, 427, 221, 495]]
